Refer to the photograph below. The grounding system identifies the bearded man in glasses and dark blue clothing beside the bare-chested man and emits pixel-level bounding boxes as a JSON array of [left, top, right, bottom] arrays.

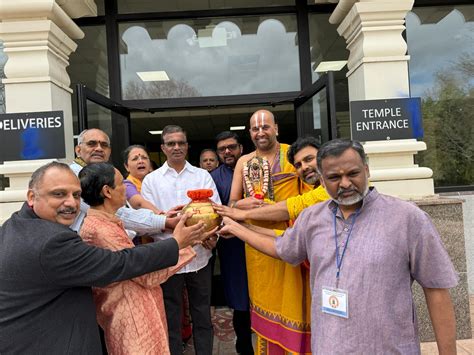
[[211, 131, 253, 355]]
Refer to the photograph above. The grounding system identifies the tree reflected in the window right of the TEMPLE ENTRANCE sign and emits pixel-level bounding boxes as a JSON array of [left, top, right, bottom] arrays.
[[419, 54, 474, 186]]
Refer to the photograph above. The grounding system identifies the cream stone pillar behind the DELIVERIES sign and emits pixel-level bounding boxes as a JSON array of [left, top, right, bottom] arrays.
[[0, 0, 97, 224]]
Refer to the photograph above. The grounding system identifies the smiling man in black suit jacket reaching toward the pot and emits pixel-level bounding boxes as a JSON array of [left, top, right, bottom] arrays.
[[0, 162, 207, 354]]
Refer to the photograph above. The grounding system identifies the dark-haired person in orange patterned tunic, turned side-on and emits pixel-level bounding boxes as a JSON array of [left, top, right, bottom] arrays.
[[79, 163, 204, 355]]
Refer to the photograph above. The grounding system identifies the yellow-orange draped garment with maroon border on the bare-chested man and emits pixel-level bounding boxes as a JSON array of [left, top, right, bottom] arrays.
[[245, 144, 311, 355]]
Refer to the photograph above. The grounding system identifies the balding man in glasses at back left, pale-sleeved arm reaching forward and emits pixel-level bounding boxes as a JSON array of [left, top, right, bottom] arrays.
[[70, 128, 177, 233]]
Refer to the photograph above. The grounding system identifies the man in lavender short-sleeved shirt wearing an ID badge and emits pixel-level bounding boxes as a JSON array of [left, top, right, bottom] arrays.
[[220, 139, 458, 354]]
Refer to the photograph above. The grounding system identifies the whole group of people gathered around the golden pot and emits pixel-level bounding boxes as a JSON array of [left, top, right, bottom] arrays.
[[0, 110, 458, 355]]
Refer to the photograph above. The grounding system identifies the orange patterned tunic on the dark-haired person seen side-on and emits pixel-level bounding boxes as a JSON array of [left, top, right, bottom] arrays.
[[80, 209, 196, 355]]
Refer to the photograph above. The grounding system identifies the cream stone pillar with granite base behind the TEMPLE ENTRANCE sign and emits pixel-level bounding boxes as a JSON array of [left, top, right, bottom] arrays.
[[329, 0, 471, 341]]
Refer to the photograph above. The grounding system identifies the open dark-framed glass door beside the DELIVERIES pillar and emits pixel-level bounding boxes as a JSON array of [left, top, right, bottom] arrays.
[[76, 84, 130, 167]]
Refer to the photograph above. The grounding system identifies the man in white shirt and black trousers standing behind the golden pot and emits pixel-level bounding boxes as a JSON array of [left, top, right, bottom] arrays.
[[141, 125, 221, 355]]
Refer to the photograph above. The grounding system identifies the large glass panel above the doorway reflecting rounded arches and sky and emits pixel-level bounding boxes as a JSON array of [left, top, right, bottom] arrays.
[[119, 15, 300, 99]]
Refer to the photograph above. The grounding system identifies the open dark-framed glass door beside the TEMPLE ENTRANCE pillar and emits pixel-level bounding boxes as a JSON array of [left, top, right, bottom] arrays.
[[294, 72, 337, 143]]
